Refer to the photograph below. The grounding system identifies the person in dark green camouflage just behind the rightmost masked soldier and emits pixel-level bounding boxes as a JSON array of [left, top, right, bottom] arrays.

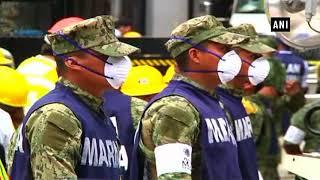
[[244, 58, 286, 180]]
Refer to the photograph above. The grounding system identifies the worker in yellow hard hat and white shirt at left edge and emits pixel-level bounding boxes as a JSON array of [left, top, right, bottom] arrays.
[[0, 66, 28, 169]]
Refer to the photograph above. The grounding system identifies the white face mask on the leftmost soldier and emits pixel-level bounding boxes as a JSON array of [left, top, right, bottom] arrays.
[[104, 56, 131, 89]]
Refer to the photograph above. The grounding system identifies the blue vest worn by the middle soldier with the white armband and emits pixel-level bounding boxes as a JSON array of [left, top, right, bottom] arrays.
[[131, 80, 242, 180]]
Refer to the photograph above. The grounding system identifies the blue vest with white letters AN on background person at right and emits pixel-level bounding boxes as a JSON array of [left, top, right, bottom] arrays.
[[275, 51, 307, 83]]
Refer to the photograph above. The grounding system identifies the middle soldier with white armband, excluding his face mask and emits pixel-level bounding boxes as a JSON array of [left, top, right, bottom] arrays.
[[131, 15, 248, 179]]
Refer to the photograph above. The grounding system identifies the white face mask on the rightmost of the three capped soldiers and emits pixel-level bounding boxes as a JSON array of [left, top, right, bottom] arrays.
[[248, 57, 270, 86]]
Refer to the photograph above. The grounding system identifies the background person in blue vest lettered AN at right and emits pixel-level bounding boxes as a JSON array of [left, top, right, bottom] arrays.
[[266, 38, 308, 134]]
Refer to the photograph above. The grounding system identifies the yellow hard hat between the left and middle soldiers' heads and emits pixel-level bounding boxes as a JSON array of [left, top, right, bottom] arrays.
[[121, 66, 166, 96]]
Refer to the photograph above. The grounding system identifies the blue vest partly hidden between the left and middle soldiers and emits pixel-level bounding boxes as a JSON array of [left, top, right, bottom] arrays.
[[103, 90, 135, 180]]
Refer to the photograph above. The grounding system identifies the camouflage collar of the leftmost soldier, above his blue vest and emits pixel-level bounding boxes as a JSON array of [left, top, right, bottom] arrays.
[[58, 78, 102, 112]]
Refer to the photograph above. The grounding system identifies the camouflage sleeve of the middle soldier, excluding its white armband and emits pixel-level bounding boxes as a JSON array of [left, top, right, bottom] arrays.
[[142, 96, 200, 180]]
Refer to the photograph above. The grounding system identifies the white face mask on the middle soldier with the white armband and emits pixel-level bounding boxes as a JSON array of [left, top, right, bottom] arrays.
[[217, 51, 242, 84]]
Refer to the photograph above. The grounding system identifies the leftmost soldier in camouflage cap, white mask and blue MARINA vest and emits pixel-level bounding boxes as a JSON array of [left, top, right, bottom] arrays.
[[9, 16, 139, 179]]
